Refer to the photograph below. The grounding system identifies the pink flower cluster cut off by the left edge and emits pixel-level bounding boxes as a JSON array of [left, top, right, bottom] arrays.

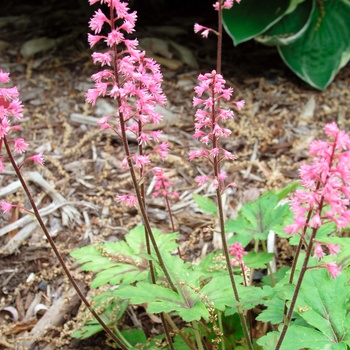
[[0, 69, 44, 175]]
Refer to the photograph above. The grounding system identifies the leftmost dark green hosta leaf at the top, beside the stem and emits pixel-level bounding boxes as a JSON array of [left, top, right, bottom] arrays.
[[223, 0, 290, 45]]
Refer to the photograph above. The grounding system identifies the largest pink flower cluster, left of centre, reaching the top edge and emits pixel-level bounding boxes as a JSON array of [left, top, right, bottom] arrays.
[[86, 0, 168, 168]]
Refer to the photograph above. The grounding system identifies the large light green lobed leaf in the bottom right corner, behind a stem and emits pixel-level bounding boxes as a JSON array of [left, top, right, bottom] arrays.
[[257, 266, 350, 350]]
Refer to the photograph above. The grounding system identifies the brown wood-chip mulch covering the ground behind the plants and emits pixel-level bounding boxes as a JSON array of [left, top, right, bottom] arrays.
[[0, 2, 350, 349]]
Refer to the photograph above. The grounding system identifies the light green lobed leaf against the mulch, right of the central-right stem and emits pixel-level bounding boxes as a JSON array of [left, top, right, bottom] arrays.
[[225, 193, 290, 247]]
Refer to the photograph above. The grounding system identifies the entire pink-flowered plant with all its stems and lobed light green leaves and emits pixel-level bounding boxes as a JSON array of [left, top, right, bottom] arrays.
[[0, 0, 350, 350]]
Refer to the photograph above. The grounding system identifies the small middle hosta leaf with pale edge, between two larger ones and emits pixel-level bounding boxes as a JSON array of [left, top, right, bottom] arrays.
[[256, 0, 316, 45]]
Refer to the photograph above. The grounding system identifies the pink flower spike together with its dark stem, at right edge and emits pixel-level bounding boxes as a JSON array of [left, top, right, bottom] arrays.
[[276, 123, 350, 349]]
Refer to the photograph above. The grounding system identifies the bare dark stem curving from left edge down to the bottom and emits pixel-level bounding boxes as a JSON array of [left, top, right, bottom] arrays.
[[3, 136, 128, 350]]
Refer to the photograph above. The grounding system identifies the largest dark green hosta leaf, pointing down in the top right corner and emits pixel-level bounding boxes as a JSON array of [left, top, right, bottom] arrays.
[[278, 0, 350, 90]]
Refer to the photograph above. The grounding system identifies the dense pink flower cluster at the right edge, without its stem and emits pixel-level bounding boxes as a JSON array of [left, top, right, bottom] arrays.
[[285, 123, 350, 276]]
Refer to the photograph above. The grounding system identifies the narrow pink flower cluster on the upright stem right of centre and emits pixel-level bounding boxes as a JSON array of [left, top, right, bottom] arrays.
[[190, 70, 244, 190]]
